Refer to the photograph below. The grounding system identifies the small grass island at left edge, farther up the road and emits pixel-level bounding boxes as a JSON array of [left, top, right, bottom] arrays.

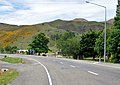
[[0, 57, 25, 64]]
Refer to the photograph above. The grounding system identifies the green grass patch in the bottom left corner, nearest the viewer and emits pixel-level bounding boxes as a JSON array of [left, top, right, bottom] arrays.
[[0, 70, 19, 85]]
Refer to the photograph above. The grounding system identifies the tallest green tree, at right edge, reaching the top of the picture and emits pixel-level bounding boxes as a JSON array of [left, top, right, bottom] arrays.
[[108, 0, 120, 62]]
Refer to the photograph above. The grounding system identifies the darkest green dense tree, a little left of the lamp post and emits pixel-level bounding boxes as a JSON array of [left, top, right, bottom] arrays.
[[80, 30, 98, 59]]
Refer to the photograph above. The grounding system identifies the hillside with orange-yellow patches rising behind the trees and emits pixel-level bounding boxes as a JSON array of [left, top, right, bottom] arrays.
[[0, 18, 112, 50]]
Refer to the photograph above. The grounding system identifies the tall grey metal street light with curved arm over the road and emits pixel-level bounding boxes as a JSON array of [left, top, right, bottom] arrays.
[[86, 1, 107, 62]]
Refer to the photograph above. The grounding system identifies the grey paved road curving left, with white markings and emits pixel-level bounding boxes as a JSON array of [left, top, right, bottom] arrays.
[[0, 55, 120, 85]]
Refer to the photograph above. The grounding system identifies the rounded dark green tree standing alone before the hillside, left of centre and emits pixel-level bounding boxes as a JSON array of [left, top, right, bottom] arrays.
[[29, 33, 49, 54]]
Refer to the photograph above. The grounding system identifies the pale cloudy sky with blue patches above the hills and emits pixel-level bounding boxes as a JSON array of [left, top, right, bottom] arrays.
[[0, 0, 117, 25]]
